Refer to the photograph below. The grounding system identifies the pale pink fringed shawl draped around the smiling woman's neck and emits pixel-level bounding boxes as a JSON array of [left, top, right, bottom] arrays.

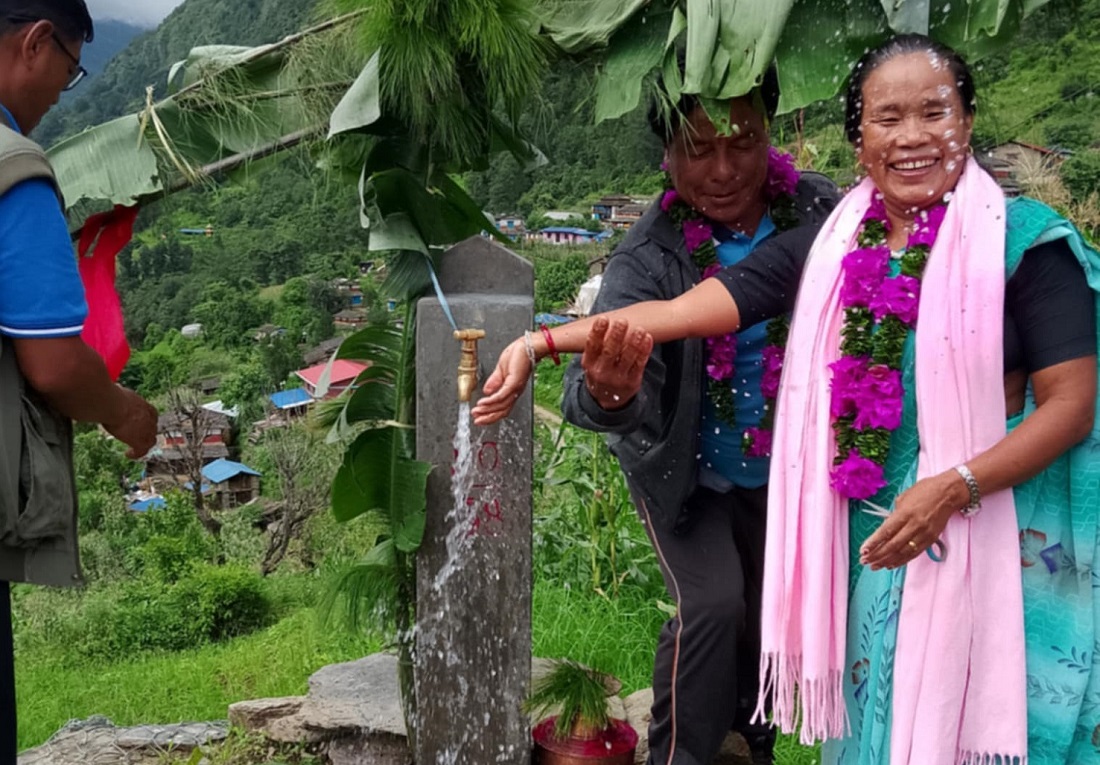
[[758, 160, 1027, 765]]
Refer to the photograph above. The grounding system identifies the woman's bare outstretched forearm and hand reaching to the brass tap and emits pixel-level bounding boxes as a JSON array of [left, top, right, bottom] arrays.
[[473, 278, 740, 425]]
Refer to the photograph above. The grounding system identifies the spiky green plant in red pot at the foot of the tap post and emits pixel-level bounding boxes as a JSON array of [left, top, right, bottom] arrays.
[[525, 659, 638, 765]]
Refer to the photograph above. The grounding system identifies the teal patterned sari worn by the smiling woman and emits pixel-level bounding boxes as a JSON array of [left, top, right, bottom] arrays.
[[822, 198, 1100, 765]]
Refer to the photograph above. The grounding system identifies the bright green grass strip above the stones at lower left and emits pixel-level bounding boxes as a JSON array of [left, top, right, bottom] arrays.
[[17, 609, 381, 748]]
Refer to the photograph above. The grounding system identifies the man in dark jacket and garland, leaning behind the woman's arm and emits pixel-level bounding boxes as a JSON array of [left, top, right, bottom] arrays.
[[562, 79, 839, 765]]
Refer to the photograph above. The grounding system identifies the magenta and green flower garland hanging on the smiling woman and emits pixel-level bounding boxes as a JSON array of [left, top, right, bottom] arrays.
[[829, 194, 947, 500]]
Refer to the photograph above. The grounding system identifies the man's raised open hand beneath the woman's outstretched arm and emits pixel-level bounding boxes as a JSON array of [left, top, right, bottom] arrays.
[[581, 318, 653, 412]]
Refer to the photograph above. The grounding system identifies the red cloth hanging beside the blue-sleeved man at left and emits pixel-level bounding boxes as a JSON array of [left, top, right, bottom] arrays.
[[77, 205, 138, 381]]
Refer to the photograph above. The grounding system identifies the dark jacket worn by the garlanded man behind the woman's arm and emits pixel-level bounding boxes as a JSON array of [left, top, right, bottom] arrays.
[[562, 173, 839, 527]]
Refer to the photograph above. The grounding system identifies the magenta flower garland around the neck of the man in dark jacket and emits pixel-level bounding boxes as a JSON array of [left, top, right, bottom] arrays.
[[661, 146, 799, 457]]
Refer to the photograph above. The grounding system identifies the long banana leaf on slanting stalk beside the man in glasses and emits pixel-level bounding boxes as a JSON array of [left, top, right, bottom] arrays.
[[48, 17, 362, 225]]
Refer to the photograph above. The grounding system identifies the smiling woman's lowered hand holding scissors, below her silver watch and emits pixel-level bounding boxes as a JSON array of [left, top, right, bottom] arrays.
[[859, 470, 970, 571]]
